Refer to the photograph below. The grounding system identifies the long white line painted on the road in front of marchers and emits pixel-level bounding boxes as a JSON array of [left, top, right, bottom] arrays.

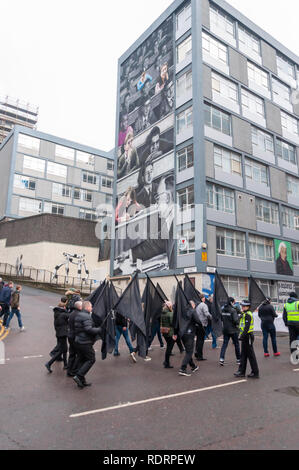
[[70, 380, 247, 418]]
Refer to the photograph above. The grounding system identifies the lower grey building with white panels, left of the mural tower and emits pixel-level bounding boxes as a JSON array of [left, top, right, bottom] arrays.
[[0, 126, 114, 220]]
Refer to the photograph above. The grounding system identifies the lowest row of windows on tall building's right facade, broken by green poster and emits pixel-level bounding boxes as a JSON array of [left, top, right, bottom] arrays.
[[216, 227, 299, 265]]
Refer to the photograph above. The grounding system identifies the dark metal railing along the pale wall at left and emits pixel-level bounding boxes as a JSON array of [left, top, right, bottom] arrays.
[[0, 263, 99, 293]]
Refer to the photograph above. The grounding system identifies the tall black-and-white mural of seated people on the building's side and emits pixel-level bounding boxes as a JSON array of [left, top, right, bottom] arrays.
[[114, 17, 176, 275]]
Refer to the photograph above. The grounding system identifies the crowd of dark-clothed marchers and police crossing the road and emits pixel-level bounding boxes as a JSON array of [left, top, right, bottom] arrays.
[[45, 282, 299, 389]]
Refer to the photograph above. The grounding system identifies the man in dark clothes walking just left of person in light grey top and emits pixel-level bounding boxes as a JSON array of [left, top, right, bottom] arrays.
[[179, 300, 200, 377]]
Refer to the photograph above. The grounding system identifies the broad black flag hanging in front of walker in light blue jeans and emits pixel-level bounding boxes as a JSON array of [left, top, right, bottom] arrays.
[[114, 273, 147, 358]]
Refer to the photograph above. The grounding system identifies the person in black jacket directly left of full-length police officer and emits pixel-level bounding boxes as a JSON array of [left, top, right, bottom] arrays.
[[219, 297, 241, 366]]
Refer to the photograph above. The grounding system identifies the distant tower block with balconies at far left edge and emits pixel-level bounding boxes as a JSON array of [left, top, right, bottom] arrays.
[[0, 96, 38, 144]]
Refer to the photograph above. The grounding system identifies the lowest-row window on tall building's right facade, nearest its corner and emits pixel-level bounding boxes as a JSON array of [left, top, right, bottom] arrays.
[[216, 228, 246, 258]]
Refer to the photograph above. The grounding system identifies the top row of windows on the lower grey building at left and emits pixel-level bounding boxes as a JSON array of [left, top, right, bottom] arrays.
[[18, 134, 114, 171]]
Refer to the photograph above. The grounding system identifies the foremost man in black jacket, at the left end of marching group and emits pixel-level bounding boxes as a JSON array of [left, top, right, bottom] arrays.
[[73, 301, 102, 388]]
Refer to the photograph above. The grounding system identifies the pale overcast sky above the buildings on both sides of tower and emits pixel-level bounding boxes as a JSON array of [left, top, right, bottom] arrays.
[[0, 0, 299, 151]]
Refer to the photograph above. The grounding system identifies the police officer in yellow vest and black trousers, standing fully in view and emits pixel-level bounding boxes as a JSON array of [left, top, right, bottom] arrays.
[[234, 300, 260, 379]]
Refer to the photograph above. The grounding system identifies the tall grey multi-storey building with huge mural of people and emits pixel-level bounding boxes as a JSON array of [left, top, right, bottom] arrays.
[[111, 0, 299, 299]]
